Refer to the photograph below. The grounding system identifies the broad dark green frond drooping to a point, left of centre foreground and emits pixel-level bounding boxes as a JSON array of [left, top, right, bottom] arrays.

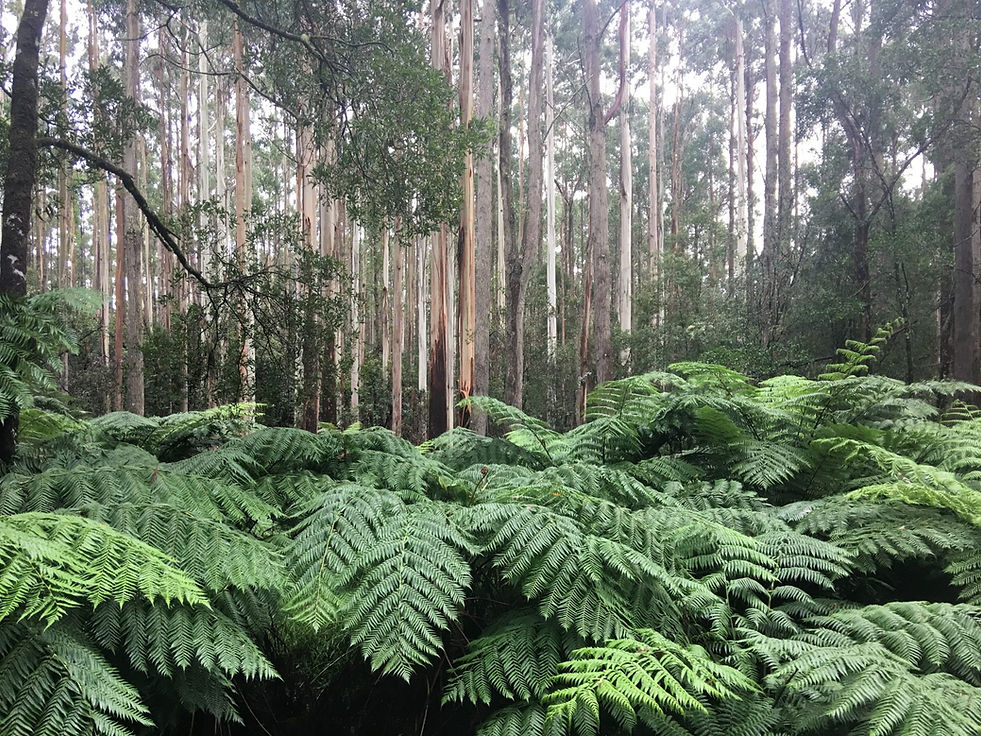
[[288, 485, 471, 679]]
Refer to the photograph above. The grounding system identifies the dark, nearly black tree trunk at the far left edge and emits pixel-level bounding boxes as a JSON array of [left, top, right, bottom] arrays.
[[0, 0, 48, 462]]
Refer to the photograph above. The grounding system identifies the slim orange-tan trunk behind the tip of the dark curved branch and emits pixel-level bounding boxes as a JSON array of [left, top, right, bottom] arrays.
[[232, 23, 255, 401]]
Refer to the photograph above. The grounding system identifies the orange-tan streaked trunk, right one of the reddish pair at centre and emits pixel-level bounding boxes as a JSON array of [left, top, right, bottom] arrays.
[[457, 0, 477, 427]]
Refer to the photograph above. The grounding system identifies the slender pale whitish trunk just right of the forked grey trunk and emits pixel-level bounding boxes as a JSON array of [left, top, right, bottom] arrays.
[[617, 2, 634, 363]]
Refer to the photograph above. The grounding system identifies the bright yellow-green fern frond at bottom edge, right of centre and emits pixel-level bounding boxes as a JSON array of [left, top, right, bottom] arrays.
[[543, 629, 756, 734]]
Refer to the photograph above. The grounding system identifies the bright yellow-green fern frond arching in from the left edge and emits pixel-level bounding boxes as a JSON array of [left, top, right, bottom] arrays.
[[0, 513, 207, 625]]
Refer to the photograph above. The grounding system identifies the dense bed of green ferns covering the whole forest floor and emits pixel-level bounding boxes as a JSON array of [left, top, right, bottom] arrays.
[[0, 331, 981, 736]]
